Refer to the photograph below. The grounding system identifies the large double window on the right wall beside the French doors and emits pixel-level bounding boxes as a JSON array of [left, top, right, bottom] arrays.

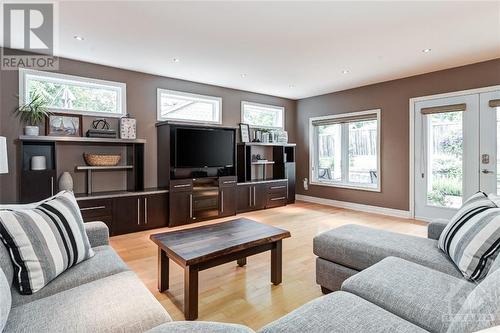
[[309, 110, 380, 191]]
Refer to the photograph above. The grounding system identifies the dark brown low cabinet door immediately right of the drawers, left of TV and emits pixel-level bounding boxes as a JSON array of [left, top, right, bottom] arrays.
[[113, 196, 140, 235]]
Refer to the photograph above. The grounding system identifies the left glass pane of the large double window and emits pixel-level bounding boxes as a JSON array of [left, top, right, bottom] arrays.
[[316, 124, 342, 182]]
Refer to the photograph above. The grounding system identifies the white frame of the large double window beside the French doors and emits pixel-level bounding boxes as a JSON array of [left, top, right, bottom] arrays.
[[309, 109, 382, 192]]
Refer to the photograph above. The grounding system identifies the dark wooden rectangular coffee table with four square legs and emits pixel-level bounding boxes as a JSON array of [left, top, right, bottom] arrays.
[[150, 218, 290, 320]]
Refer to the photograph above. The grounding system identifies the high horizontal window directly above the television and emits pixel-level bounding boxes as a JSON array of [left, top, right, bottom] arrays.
[[157, 89, 222, 124]]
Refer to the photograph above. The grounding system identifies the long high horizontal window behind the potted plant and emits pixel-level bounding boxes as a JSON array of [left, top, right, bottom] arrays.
[[19, 69, 127, 117]]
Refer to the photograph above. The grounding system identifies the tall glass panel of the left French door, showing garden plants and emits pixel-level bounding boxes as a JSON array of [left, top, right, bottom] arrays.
[[426, 112, 463, 208]]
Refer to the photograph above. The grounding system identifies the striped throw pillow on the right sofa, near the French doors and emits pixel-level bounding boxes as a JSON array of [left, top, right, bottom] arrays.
[[438, 192, 500, 281]]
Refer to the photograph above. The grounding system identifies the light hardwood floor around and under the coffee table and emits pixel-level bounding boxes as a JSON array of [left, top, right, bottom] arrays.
[[111, 202, 427, 329]]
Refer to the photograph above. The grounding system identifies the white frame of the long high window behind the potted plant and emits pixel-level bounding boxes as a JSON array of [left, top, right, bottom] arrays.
[[19, 68, 127, 118]]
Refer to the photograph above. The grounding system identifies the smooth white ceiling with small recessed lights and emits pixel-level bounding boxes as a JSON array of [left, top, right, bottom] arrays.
[[34, 1, 500, 99]]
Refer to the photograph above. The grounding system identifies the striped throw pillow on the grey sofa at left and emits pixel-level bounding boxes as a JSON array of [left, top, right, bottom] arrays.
[[0, 191, 94, 295]]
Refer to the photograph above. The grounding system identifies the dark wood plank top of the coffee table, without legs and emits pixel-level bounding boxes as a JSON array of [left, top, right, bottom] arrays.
[[150, 218, 290, 266]]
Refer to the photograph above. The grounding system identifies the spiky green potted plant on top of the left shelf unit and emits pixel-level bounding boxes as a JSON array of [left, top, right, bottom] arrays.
[[15, 94, 51, 136]]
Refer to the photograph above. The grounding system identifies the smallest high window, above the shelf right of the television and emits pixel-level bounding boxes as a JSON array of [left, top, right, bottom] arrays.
[[241, 102, 285, 129]]
